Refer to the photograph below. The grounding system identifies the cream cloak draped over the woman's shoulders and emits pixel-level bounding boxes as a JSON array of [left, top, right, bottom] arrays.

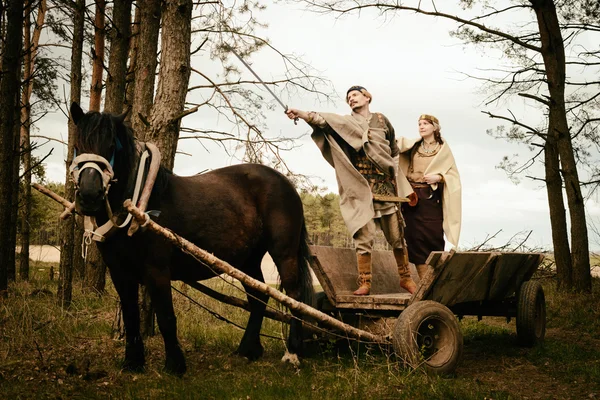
[[397, 137, 462, 247]]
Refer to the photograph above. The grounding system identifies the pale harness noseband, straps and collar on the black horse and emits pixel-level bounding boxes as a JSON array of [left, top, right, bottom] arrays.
[[69, 143, 160, 258]]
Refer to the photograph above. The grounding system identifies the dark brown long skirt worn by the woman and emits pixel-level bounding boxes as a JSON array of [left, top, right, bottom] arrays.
[[402, 183, 444, 264]]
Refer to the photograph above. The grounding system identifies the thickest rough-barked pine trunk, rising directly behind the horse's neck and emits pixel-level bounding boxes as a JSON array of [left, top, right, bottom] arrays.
[[147, 0, 192, 170]]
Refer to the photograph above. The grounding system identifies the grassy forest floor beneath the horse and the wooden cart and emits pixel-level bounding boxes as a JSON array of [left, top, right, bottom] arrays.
[[0, 263, 600, 400]]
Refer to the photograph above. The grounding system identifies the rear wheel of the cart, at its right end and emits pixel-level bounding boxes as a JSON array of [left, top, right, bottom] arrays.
[[517, 281, 546, 347]]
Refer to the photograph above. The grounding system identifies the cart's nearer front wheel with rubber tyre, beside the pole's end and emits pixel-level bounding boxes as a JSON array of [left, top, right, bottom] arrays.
[[393, 300, 463, 375]]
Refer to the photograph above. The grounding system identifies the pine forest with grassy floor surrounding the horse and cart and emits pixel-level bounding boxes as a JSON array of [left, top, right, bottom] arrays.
[[0, 0, 600, 399]]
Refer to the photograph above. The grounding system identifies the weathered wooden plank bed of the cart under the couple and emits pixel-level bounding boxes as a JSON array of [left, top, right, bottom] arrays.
[[310, 246, 543, 311]]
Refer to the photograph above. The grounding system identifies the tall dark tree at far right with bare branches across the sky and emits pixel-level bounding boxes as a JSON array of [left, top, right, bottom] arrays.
[[304, 0, 600, 292]]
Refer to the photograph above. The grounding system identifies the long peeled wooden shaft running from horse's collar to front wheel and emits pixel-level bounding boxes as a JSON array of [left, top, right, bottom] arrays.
[[123, 200, 389, 344]]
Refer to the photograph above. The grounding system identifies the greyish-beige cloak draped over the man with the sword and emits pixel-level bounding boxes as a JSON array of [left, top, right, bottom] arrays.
[[311, 113, 413, 236]]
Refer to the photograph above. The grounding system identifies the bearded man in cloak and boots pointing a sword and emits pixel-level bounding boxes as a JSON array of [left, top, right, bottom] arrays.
[[286, 86, 416, 296]]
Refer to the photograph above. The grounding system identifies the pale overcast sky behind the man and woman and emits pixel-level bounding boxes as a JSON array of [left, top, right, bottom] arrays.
[[39, 3, 600, 249]]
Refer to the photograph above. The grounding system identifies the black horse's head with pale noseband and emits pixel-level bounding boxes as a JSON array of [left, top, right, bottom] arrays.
[[69, 103, 135, 215]]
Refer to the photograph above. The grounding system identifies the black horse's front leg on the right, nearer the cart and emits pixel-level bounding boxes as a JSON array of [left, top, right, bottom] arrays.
[[146, 267, 187, 376]]
